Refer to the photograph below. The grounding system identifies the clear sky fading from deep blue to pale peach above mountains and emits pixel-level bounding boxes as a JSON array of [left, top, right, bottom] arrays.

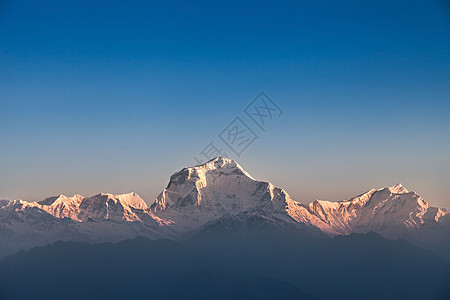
[[0, 0, 450, 208]]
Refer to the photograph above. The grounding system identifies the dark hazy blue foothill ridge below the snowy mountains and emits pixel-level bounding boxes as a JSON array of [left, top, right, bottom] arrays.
[[0, 232, 450, 300]]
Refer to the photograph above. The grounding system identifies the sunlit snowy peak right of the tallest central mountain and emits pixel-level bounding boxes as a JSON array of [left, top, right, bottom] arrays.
[[308, 184, 446, 238]]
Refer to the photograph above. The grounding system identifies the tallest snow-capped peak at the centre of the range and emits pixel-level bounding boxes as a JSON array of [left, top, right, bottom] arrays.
[[151, 157, 293, 230]]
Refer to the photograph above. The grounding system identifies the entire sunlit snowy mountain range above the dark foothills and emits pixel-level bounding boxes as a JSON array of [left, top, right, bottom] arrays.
[[0, 157, 450, 255]]
